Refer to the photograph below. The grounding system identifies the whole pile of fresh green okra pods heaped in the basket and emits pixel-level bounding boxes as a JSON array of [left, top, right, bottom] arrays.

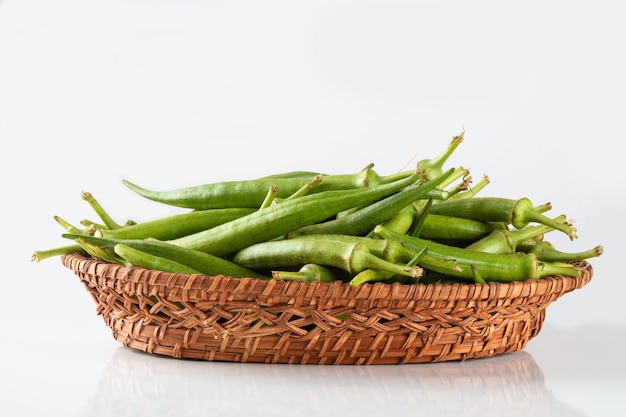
[[33, 134, 603, 286]]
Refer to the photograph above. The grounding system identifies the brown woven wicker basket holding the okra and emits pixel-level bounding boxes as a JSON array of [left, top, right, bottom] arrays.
[[62, 250, 593, 365]]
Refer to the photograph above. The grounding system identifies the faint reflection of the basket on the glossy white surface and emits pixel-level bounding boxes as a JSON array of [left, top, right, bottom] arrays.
[[77, 347, 584, 417]]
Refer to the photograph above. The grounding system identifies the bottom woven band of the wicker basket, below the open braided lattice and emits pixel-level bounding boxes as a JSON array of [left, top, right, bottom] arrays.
[[107, 310, 545, 365]]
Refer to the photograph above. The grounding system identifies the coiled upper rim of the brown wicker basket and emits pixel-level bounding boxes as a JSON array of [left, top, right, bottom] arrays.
[[61, 253, 593, 301]]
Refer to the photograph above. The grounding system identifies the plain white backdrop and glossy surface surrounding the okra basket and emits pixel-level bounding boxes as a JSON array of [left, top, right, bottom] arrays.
[[0, 0, 626, 417]]
